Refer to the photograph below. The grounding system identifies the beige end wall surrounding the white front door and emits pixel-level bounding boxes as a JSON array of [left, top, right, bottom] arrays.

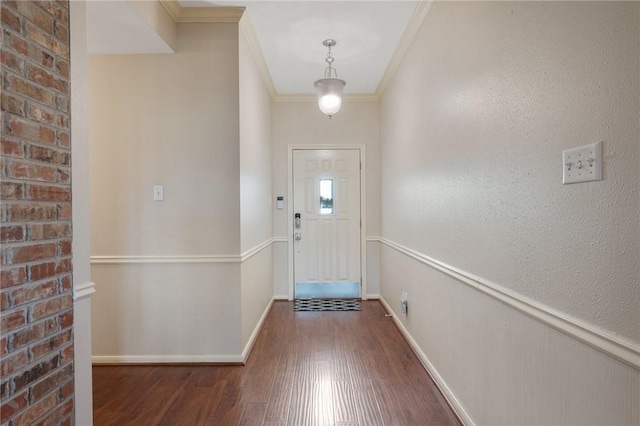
[[273, 101, 380, 297]]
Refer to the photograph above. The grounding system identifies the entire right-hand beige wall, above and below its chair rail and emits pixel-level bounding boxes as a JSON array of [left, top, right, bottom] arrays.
[[381, 2, 640, 425]]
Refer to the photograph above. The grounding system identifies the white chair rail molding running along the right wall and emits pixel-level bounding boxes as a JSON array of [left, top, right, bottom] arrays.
[[380, 237, 640, 370]]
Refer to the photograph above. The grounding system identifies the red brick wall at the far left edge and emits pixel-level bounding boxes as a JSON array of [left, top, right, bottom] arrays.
[[0, 0, 74, 426]]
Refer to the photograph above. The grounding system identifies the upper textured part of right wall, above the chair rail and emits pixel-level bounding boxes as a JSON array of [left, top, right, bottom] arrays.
[[382, 2, 640, 342]]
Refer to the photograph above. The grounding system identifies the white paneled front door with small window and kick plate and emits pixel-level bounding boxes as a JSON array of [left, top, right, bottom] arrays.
[[293, 149, 361, 297]]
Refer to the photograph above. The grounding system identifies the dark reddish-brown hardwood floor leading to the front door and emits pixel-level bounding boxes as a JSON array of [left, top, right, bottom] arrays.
[[93, 301, 459, 426]]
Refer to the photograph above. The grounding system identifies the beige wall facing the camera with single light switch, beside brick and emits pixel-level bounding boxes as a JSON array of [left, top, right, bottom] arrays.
[[89, 24, 242, 362]]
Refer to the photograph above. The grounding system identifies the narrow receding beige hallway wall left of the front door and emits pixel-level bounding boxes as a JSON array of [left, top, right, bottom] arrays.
[[239, 23, 273, 353]]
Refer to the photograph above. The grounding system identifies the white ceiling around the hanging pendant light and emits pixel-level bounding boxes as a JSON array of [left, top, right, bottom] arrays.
[[87, 0, 418, 95]]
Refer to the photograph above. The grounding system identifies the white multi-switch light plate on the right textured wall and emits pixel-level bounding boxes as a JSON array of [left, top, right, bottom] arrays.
[[562, 142, 602, 185]]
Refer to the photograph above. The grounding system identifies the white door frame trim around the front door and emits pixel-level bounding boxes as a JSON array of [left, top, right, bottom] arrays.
[[287, 144, 367, 300]]
